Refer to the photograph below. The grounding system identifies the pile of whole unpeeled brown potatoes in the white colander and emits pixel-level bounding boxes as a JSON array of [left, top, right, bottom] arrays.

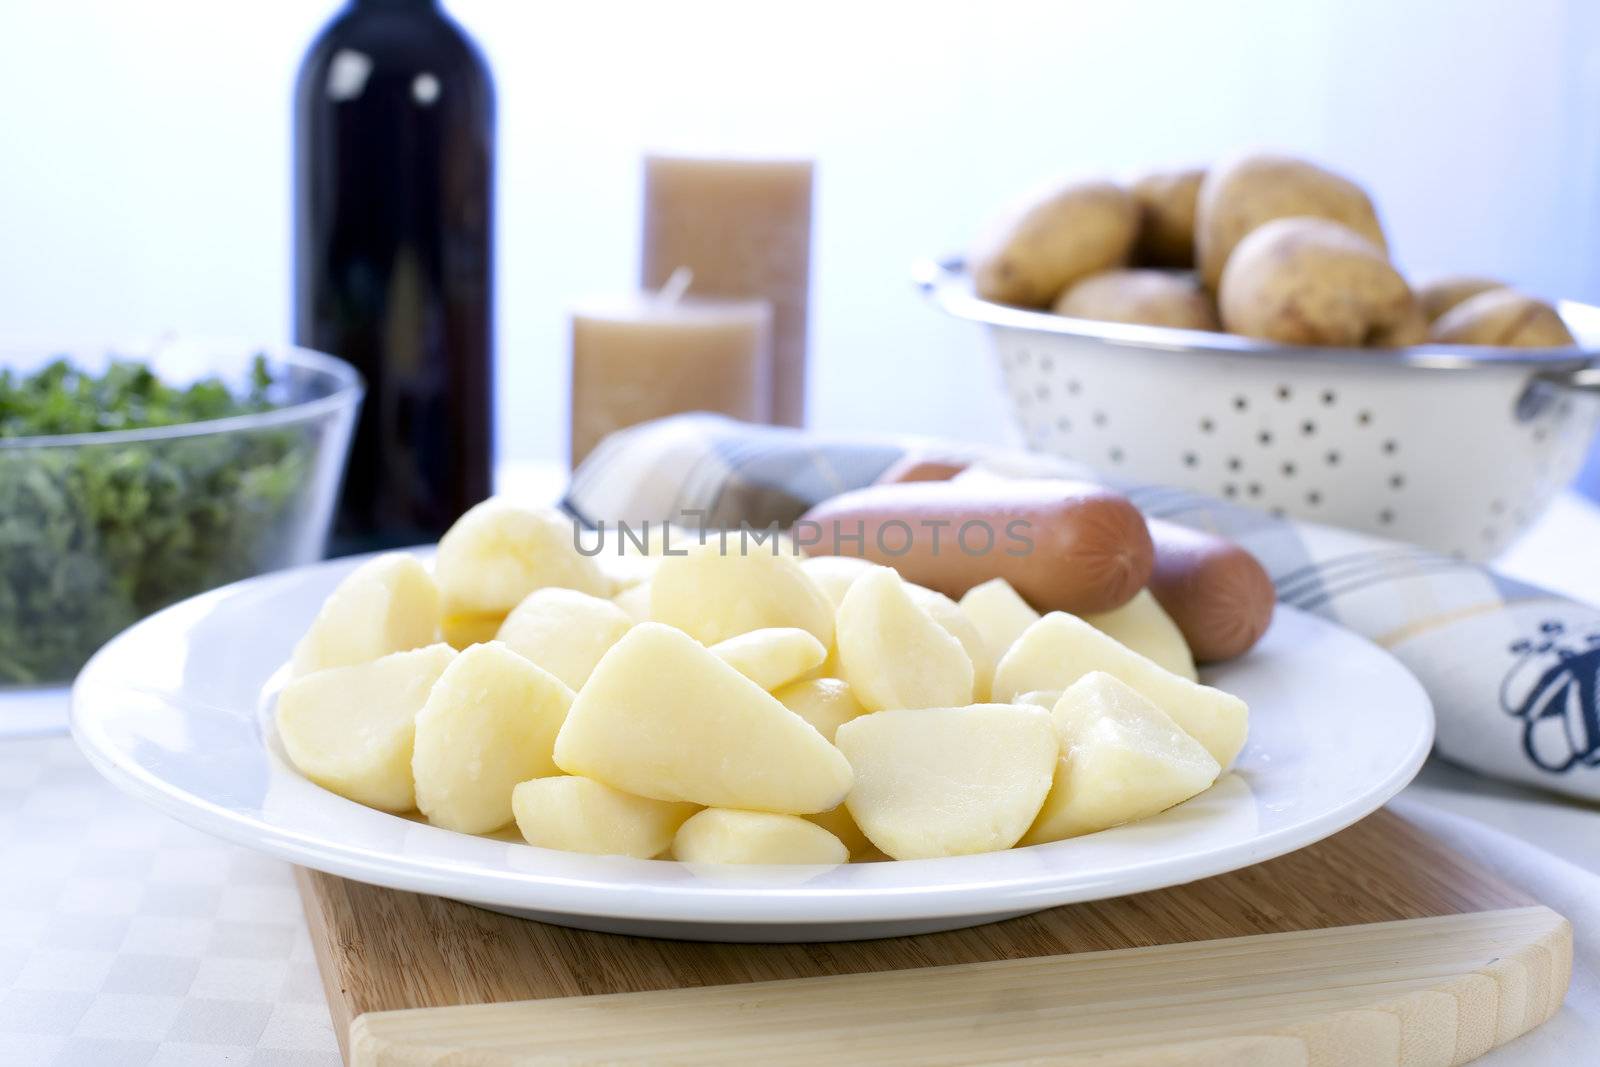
[[970, 152, 1574, 347]]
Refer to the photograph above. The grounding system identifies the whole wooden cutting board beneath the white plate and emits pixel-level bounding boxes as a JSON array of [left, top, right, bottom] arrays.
[[299, 811, 1571, 1067]]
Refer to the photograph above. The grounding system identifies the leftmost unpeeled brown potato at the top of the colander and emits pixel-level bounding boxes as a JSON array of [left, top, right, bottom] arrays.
[[970, 181, 1139, 307]]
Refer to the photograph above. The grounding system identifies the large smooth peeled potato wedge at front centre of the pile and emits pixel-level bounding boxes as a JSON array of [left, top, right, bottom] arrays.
[[555, 622, 851, 814]]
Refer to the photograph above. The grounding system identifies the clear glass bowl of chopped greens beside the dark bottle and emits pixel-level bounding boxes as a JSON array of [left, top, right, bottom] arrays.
[[0, 341, 362, 688]]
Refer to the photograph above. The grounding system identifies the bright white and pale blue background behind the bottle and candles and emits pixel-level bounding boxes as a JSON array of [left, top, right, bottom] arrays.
[[0, 0, 1600, 458]]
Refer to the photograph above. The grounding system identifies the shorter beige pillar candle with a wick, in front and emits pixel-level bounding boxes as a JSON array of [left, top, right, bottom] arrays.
[[571, 293, 773, 467]]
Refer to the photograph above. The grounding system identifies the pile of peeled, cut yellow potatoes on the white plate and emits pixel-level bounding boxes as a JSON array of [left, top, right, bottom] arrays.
[[277, 499, 1248, 864]]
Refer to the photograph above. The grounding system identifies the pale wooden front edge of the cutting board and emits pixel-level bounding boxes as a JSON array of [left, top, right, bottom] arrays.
[[350, 907, 1571, 1067]]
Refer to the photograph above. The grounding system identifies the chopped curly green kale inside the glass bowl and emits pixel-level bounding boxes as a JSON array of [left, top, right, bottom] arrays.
[[0, 357, 315, 685]]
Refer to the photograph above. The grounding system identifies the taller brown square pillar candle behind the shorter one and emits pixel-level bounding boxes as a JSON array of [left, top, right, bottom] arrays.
[[642, 155, 813, 426]]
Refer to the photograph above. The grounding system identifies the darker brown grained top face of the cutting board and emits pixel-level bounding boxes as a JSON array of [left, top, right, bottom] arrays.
[[299, 811, 1561, 1062]]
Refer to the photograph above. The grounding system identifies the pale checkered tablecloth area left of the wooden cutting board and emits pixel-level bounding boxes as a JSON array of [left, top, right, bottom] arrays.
[[0, 736, 339, 1067]]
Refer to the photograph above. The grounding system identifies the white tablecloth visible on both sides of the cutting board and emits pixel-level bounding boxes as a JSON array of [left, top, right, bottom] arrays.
[[0, 476, 1600, 1067]]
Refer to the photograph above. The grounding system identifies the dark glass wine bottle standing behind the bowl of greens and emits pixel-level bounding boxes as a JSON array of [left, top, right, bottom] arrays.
[[294, 0, 494, 555]]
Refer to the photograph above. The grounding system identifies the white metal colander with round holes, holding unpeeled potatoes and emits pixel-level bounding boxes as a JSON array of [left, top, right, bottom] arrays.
[[918, 262, 1600, 560]]
